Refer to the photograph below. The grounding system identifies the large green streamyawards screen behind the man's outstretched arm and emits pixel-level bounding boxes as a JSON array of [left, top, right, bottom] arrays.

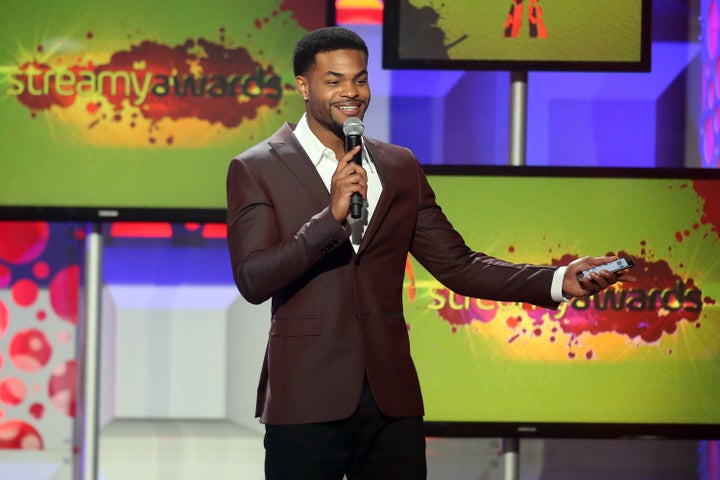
[[404, 167, 720, 438]]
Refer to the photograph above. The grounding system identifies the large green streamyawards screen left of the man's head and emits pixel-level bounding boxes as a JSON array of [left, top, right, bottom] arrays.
[[0, 0, 333, 220]]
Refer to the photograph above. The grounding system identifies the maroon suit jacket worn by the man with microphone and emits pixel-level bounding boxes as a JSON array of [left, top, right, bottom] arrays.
[[227, 124, 557, 424]]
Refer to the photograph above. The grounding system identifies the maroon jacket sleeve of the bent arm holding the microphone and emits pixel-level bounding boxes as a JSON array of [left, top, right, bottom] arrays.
[[227, 157, 348, 304]]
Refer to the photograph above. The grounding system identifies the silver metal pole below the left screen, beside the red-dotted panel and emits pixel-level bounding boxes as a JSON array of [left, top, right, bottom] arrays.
[[73, 223, 102, 480]]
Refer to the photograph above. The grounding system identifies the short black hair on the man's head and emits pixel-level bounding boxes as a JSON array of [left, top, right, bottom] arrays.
[[293, 27, 368, 76]]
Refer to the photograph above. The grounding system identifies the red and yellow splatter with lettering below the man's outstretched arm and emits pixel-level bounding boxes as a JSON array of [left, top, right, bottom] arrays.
[[429, 252, 716, 360]]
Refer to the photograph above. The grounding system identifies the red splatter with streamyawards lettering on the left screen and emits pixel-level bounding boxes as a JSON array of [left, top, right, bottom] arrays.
[[13, 38, 283, 133]]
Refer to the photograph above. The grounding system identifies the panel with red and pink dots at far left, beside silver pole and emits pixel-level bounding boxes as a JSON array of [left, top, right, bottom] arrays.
[[0, 221, 85, 449]]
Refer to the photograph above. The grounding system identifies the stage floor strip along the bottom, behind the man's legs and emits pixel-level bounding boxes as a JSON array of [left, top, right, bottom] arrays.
[[0, 419, 696, 480]]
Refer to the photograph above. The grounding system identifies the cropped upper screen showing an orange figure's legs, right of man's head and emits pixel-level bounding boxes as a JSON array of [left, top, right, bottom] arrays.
[[383, 0, 651, 71]]
